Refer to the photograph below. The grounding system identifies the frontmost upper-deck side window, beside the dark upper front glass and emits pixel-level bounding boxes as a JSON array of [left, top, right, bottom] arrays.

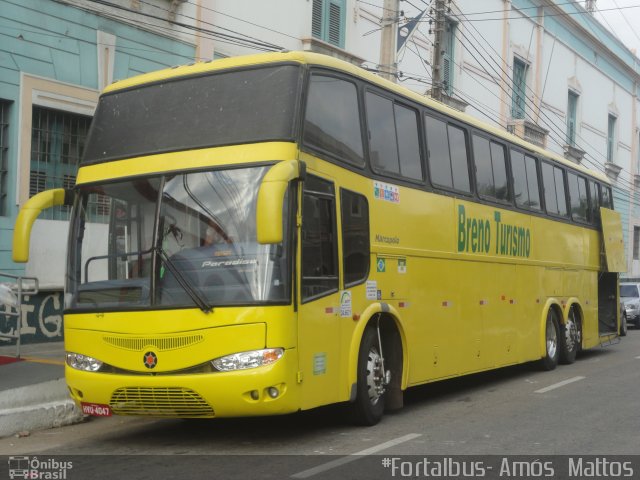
[[304, 74, 364, 165]]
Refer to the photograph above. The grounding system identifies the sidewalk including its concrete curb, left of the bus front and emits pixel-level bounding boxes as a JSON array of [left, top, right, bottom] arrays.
[[0, 342, 83, 438]]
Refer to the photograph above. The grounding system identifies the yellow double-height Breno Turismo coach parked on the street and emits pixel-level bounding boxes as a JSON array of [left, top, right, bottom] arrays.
[[14, 52, 624, 425]]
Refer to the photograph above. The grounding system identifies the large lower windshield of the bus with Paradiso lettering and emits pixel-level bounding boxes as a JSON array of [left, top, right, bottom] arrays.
[[66, 166, 291, 310]]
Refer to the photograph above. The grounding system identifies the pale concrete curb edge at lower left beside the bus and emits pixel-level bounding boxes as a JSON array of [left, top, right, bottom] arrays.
[[0, 378, 84, 438]]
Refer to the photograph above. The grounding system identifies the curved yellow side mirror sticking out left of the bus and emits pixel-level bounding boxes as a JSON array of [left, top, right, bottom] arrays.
[[12, 188, 73, 263]]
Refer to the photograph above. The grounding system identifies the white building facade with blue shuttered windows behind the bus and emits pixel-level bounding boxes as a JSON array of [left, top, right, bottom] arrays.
[[207, 0, 640, 277]]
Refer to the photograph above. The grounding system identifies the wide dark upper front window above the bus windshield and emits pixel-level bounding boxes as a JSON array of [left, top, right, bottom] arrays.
[[83, 65, 300, 164]]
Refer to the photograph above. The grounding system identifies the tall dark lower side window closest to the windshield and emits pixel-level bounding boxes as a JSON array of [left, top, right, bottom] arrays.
[[302, 175, 338, 301]]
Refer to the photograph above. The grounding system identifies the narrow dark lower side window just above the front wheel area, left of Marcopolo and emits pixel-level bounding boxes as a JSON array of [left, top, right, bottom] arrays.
[[340, 190, 369, 287]]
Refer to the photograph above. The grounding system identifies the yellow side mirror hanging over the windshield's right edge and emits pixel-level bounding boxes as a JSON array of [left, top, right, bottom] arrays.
[[256, 160, 304, 245]]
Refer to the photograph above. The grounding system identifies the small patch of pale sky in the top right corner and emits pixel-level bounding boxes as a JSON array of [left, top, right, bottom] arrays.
[[592, 0, 640, 57]]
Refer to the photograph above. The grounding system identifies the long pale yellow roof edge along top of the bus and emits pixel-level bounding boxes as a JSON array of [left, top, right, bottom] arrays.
[[103, 51, 611, 184]]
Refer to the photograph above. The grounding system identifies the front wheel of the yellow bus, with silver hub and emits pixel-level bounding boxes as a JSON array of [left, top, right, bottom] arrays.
[[352, 327, 384, 426]]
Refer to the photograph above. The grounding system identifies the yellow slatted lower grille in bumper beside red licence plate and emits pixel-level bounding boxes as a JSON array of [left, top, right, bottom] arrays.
[[110, 387, 215, 418]]
